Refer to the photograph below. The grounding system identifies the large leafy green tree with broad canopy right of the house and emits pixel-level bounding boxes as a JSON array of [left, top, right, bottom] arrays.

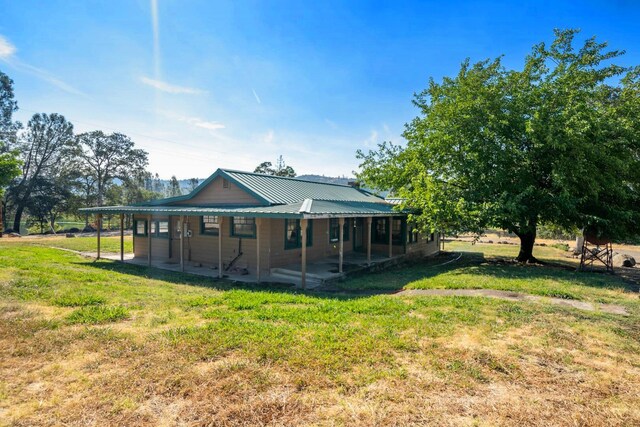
[[357, 30, 640, 262]]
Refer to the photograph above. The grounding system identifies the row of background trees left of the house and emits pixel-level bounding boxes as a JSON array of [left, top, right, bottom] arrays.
[[0, 71, 198, 236]]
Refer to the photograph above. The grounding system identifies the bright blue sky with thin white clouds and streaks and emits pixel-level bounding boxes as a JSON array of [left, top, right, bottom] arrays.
[[0, 0, 640, 178]]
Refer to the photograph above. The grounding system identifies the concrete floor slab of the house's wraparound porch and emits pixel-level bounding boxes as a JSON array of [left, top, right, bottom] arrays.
[[92, 252, 398, 289]]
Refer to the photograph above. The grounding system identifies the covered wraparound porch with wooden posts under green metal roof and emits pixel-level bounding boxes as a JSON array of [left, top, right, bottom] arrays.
[[82, 200, 406, 289]]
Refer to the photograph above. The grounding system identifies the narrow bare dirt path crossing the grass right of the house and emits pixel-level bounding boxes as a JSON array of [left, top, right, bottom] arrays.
[[394, 289, 629, 316]]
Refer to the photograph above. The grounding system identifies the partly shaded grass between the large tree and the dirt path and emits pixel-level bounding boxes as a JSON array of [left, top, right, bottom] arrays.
[[338, 242, 638, 309]]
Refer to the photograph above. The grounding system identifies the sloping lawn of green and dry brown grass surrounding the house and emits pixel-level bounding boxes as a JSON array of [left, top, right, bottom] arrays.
[[0, 238, 640, 426]]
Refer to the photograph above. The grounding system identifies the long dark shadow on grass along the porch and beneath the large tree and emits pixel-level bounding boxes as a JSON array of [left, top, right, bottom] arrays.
[[79, 252, 638, 299]]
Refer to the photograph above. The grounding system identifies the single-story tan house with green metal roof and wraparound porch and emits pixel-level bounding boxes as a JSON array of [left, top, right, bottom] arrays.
[[83, 169, 439, 286]]
